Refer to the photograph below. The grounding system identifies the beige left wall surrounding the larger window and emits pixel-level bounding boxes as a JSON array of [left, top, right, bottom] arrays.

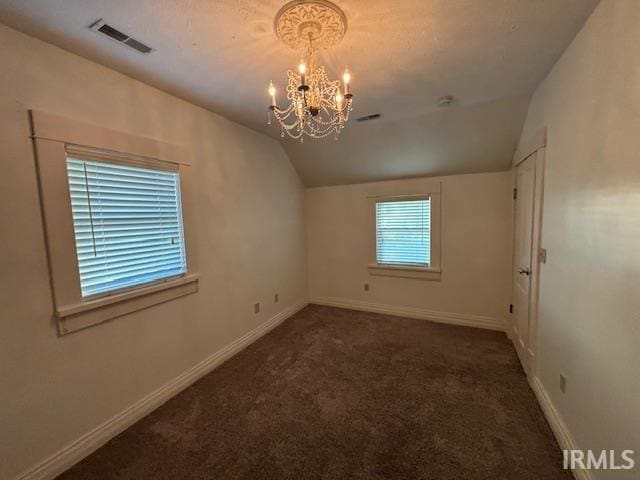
[[0, 26, 306, 479]]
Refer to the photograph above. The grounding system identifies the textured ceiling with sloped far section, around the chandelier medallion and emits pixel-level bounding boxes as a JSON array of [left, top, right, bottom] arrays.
[[0, 0, 598, 185]]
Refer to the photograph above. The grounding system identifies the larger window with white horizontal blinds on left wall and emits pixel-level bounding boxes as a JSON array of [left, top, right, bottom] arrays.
[[67, 157, 186, 298]]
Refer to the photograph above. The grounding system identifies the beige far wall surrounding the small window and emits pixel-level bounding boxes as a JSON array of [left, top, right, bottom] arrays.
[[306, 172, 513, 319]]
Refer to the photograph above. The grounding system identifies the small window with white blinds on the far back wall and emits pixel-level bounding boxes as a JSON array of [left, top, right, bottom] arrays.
[[376, 198, 431, 267]]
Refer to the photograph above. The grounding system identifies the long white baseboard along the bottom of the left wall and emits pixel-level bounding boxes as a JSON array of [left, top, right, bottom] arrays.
[[15, 301, 307, 480]]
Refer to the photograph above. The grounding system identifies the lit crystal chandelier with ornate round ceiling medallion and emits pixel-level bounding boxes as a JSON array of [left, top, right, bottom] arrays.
[[267, 0, 353, 142]]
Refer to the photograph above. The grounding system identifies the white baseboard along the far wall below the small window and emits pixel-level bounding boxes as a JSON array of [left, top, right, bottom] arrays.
[[309, 297, 506, 332]]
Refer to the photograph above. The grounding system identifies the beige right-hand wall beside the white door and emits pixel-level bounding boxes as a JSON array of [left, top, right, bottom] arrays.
[[522, 0, 640, 479]]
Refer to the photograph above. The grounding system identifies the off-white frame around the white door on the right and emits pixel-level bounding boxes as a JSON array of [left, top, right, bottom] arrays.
[[507, 127, 547, 378]]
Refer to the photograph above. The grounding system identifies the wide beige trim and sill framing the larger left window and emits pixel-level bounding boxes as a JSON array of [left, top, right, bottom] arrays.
[[30, 110, 199, 335]]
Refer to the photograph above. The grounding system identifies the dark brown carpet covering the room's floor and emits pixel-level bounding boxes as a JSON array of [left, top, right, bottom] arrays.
[[58, 305, 571, 480]]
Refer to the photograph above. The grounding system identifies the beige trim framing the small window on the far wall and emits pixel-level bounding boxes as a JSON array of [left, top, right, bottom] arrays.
[[367, 188, 442, 280]]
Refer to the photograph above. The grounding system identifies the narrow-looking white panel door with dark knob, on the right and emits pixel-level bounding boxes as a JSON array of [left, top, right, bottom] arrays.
[[513, 153, 537, 373]]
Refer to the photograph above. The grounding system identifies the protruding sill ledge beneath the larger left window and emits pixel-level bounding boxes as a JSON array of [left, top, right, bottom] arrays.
[[56, 274, 199, 335]]
